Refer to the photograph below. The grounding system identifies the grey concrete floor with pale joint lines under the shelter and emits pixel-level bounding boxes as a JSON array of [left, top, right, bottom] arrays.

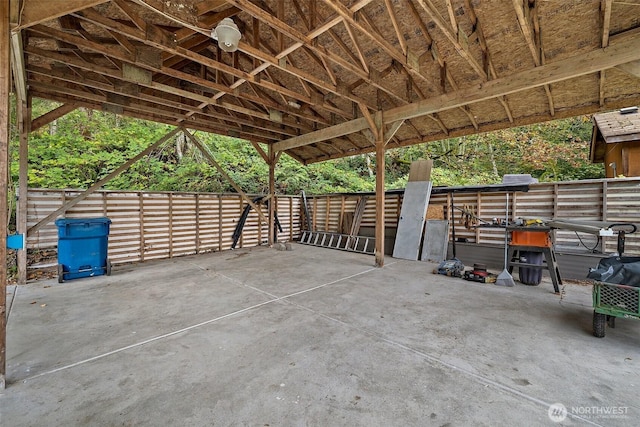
[[0, 245, 640, 427]]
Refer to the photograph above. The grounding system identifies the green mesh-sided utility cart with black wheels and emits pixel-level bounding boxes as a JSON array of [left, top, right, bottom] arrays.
[[593, 282, 640, 338]]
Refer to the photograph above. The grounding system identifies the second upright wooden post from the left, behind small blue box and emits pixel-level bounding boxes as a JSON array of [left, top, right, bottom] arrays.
[[16, 98, 31, 285]]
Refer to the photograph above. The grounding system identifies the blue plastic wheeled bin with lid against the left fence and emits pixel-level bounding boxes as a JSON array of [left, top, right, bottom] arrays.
[[56, 217, 111, 283]]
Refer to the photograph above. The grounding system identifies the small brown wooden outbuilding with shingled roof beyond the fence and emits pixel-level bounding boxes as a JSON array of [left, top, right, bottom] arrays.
[[589, 107, 640, 178]]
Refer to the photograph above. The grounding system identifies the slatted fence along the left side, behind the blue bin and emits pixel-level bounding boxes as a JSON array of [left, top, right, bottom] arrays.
[[27, 189, 300, 264]]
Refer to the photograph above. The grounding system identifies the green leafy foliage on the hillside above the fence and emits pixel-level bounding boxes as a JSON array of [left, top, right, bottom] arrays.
[[11, 100, 604, 194]]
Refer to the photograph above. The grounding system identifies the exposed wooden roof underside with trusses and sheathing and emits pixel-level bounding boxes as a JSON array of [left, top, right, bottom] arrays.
[[10, 0, 640, 164]]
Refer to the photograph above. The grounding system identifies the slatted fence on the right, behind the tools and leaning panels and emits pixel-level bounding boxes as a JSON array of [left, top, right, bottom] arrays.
[[309, 178, 640, 255]]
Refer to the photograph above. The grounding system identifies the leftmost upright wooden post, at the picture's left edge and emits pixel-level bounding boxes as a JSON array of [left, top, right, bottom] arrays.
[[0, 1, 11, 390]]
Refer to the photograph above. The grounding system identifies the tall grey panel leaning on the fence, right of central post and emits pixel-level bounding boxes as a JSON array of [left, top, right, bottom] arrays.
[[393, 181, 431, 261]]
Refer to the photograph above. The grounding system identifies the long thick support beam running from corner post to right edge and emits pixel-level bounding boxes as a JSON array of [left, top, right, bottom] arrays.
[[275, 37, 640, 150]]
